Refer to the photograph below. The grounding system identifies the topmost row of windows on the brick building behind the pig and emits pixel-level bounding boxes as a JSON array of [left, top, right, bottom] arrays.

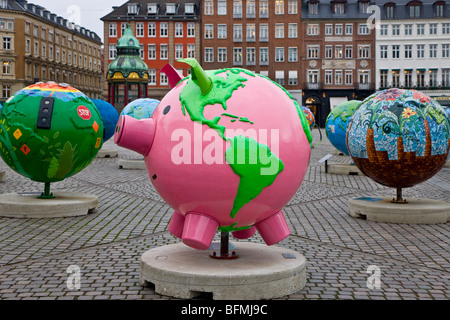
[[203, 0, 298, 19]]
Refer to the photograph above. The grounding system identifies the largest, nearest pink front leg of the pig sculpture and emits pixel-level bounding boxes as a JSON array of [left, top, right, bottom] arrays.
[[182, 212, 219, 250]]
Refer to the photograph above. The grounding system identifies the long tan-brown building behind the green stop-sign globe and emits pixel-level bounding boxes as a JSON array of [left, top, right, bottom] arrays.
[[0, 0, 104, 101]]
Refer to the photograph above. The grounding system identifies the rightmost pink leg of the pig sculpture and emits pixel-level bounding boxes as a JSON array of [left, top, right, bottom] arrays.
[[255, 210, 291, 246]]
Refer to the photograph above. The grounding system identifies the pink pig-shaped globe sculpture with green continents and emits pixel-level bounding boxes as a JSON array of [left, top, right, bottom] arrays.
[[114, 59, 312, 250]]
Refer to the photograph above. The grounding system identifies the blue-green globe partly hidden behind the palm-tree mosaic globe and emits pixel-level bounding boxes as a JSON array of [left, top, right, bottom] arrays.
[[325, 100, 362, 155]]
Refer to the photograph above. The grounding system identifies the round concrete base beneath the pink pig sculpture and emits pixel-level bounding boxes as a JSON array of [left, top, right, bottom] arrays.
[[140, 242, 306, 300]]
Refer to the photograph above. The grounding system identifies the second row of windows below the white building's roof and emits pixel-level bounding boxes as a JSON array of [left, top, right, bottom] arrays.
[[380, 43, 450, 59]]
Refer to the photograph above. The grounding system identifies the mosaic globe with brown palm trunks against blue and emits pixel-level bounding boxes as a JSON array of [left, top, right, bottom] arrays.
[[347, 89, 450, 188]]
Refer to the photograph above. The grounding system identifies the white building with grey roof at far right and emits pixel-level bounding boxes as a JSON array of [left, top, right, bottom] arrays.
[[376, 1, 450, 106]]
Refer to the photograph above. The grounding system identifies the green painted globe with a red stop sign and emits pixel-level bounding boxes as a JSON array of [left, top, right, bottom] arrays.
[[0, 82, 103, 183]]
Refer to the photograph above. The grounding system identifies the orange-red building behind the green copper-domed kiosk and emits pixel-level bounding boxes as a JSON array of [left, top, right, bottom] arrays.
[[101, 0, 201, 99]]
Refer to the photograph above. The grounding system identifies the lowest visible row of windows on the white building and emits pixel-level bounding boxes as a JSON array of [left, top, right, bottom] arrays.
[[380, 69, 450, 88]]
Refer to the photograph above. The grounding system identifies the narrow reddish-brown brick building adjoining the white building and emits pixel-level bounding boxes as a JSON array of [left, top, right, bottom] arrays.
[[301, 0, 376, 126]]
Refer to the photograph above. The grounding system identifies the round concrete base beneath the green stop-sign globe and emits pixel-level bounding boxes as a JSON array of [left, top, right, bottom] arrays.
[[0, 192, 98, 218]]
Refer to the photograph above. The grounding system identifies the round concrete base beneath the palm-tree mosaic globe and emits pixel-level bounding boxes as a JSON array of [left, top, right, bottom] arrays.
[[348, 197, 450, 224]]
